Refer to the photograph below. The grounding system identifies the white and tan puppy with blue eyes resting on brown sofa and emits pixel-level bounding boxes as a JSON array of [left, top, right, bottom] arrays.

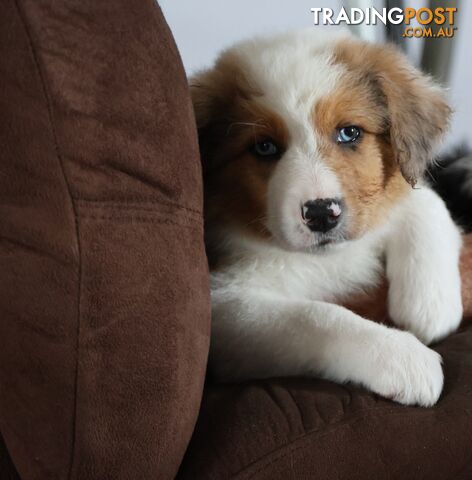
[[191, 30, 462, 406]]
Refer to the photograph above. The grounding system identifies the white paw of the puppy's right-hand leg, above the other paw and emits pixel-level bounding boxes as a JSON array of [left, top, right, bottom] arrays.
[[388, 281, 463, 345]]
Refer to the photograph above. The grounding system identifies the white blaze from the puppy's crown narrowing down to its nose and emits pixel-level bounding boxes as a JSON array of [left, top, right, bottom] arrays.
[[225, 29, 347, 200]]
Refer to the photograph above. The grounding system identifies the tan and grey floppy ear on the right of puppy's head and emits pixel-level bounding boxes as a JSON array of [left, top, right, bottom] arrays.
[[339, 41, 451, 185]]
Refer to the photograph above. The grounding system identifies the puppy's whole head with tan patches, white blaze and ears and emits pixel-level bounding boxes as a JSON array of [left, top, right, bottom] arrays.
[[191, 31, 450, 255]]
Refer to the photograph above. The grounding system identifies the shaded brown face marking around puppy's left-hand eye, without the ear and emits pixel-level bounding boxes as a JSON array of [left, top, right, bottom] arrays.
[[203, 104, 288, 237]]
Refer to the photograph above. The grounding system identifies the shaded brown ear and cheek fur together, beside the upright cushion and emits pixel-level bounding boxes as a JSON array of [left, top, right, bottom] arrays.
[[191, 61, 289, 262]]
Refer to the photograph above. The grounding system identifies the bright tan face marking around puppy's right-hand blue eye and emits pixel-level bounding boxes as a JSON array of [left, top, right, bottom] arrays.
[[313, 75, 408, 237]]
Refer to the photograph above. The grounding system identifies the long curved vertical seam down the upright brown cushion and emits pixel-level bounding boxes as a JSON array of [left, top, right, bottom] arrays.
[[14, 0, 82, 479]]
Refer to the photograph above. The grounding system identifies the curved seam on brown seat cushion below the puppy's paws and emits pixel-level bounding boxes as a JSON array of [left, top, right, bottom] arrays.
[[231, 408, 460, 480]]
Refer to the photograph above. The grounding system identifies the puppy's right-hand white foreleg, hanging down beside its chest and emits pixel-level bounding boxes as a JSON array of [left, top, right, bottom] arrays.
[[387, 187, 462, 343]]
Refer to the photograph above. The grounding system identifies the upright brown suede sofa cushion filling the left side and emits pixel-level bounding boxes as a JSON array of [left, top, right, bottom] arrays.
[[0, 0, 209, 480]]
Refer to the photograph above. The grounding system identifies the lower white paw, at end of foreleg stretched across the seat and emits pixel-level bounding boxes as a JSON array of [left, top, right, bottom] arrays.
[[367, 329, 444, 407]]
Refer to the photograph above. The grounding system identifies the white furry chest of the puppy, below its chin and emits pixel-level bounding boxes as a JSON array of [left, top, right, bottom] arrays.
[[213, 231, 384, 301]]
